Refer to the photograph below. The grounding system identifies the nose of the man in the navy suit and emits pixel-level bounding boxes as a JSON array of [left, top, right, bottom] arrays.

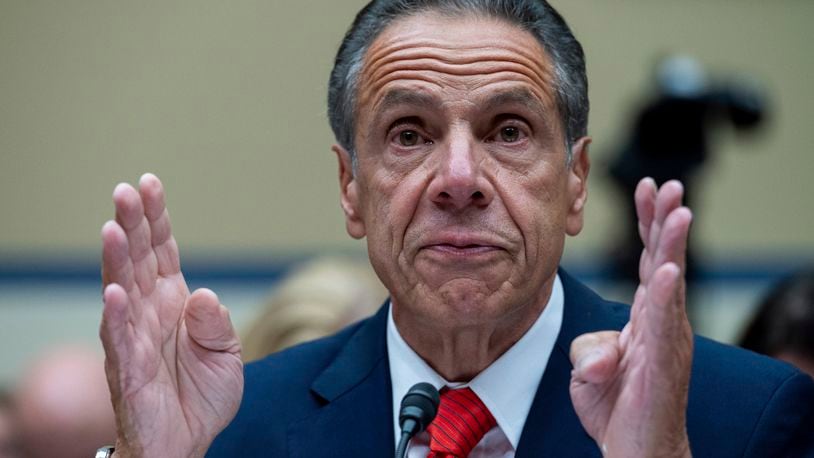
[[428, 135, 495, 210]]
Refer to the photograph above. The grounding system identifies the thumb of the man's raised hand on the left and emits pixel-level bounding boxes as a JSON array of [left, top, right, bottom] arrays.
[[184, 288, 240, 353]]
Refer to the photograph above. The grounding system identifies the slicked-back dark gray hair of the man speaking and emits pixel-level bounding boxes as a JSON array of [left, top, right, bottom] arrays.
[[328, 0, 589, 168]]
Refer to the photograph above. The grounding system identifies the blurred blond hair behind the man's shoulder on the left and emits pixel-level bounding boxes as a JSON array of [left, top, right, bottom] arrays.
[[242, 257, 388, 361]]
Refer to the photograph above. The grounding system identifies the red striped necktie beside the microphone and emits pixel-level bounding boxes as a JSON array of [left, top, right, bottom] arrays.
[[427, 388, 497, 458]]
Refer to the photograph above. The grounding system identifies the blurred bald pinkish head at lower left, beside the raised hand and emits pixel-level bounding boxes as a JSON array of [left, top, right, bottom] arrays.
[[13, 347, 116, 458]]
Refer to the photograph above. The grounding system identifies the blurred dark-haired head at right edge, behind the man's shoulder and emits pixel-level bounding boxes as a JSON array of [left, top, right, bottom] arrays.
[[740, 268, 814, 377]]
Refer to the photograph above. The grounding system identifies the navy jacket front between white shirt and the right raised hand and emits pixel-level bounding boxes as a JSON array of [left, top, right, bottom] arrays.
[[516, 269, 627, 458]]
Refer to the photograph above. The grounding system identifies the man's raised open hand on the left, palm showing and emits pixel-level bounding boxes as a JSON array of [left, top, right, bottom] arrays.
[[99, 174, 243, 457]]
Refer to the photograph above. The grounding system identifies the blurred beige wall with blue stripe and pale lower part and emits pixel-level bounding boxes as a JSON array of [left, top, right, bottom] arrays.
[[0, 0, 814, 450]]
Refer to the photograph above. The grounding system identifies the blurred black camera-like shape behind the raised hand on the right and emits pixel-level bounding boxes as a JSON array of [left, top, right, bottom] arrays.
[[608, 54, 768, 293]]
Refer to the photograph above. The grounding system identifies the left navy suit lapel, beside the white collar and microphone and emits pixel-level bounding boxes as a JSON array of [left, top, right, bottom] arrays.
[[288, 306, 396, 458]]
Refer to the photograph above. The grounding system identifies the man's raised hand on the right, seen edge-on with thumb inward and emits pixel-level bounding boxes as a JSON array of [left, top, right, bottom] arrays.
[[570, 178, 693, 457]]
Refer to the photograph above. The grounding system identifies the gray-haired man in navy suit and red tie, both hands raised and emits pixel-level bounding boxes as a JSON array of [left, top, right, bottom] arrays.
[[100, 0, 814, 457]]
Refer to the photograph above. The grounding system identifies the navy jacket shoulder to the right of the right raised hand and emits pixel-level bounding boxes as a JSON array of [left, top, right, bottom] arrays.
[[687, 337, 814, 456]]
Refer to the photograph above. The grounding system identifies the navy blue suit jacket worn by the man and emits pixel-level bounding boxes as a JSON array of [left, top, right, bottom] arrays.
[[207, 270, 814, 458]]
